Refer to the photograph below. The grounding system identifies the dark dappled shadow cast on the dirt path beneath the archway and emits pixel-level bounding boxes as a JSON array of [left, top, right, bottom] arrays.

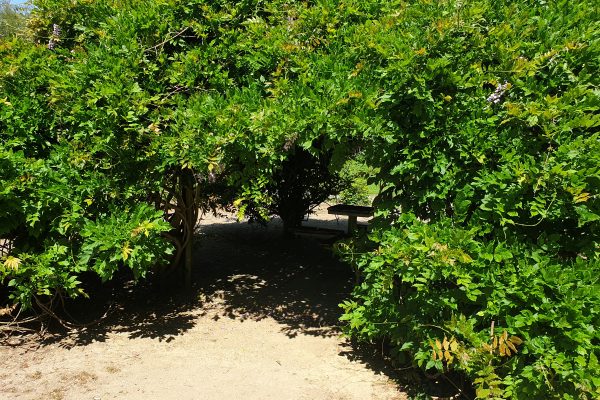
[[36, 214, 352, 346]]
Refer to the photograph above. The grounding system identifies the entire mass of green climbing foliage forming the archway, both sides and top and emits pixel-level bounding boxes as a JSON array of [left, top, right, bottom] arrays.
[[0, 0, 600, 399]]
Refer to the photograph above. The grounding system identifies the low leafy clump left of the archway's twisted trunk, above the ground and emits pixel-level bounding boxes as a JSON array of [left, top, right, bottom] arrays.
[[0, 205, 171, 307]]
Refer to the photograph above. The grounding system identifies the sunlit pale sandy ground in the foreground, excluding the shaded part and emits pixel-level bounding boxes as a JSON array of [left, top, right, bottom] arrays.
[[0, 312, 401, 400]]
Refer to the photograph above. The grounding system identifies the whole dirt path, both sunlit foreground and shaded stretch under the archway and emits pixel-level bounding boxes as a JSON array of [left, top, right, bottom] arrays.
[[0, 209, 406, 400]]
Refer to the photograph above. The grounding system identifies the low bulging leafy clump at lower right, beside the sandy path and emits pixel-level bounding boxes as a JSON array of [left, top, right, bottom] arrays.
[[342, 214, 600, 399]]
